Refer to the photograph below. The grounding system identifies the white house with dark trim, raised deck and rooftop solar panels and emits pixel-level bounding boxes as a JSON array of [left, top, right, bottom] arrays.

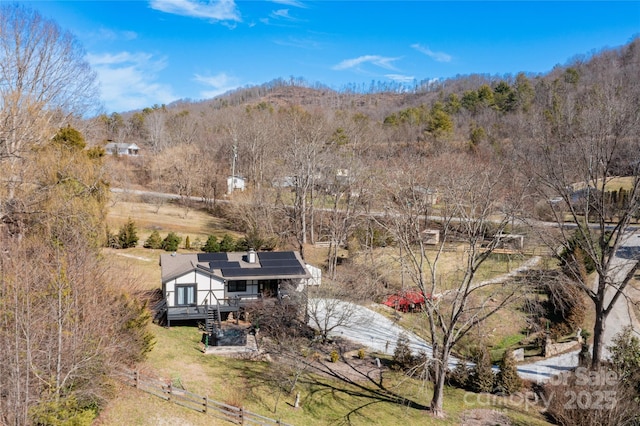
[[160, 250, 316, 333]]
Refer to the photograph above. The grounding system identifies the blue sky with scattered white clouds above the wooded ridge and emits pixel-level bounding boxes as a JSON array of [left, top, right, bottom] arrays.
[[24, 0, 640, 113]]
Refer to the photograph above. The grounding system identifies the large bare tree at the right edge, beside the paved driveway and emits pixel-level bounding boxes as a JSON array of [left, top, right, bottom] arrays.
[[519, 46, 640, 368]]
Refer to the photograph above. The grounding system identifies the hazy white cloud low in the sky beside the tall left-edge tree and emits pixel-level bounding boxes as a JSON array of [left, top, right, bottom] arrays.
[[87, 52, 177, 112]]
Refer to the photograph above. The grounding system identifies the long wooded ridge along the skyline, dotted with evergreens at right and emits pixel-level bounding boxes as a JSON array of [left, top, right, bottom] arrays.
[[85, 38, 640, 166]]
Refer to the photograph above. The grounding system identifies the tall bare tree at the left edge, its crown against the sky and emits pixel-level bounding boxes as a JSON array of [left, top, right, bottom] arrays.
[[0, 4, 97, 220]]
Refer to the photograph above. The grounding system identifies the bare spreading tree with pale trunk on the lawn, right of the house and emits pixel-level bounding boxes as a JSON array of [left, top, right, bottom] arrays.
[[380, 154, 516, 417]]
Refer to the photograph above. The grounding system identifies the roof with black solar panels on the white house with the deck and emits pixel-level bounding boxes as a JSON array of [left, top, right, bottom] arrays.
[[160, 251, 311, 283]]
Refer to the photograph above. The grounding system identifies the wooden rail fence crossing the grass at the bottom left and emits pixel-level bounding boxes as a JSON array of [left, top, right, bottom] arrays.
[[120, 371, 291, 426]]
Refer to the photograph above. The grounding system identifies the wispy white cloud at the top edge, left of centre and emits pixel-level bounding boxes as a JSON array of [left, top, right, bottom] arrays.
[[149, 0, 242, 22]]
